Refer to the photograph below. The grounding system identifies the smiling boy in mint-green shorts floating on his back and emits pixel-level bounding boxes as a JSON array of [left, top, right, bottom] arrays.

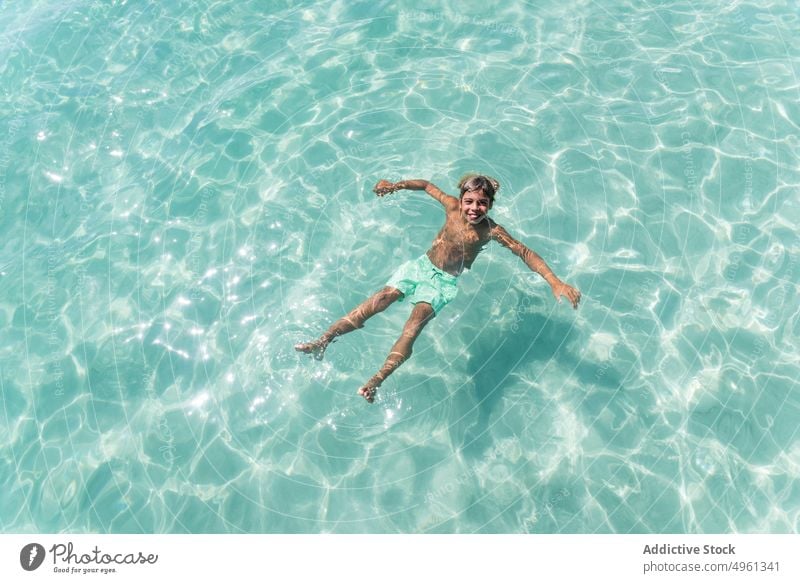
[[295, 174, 581, 403]]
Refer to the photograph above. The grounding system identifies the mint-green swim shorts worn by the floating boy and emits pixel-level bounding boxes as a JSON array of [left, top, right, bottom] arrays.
[[386, 255, 458, 314]]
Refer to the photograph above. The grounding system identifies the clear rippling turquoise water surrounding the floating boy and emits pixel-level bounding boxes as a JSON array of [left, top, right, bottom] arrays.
[[0, 0, 800, 533]]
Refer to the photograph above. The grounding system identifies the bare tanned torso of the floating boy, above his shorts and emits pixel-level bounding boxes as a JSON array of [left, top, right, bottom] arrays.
[[428, 209, 494, 275]]
